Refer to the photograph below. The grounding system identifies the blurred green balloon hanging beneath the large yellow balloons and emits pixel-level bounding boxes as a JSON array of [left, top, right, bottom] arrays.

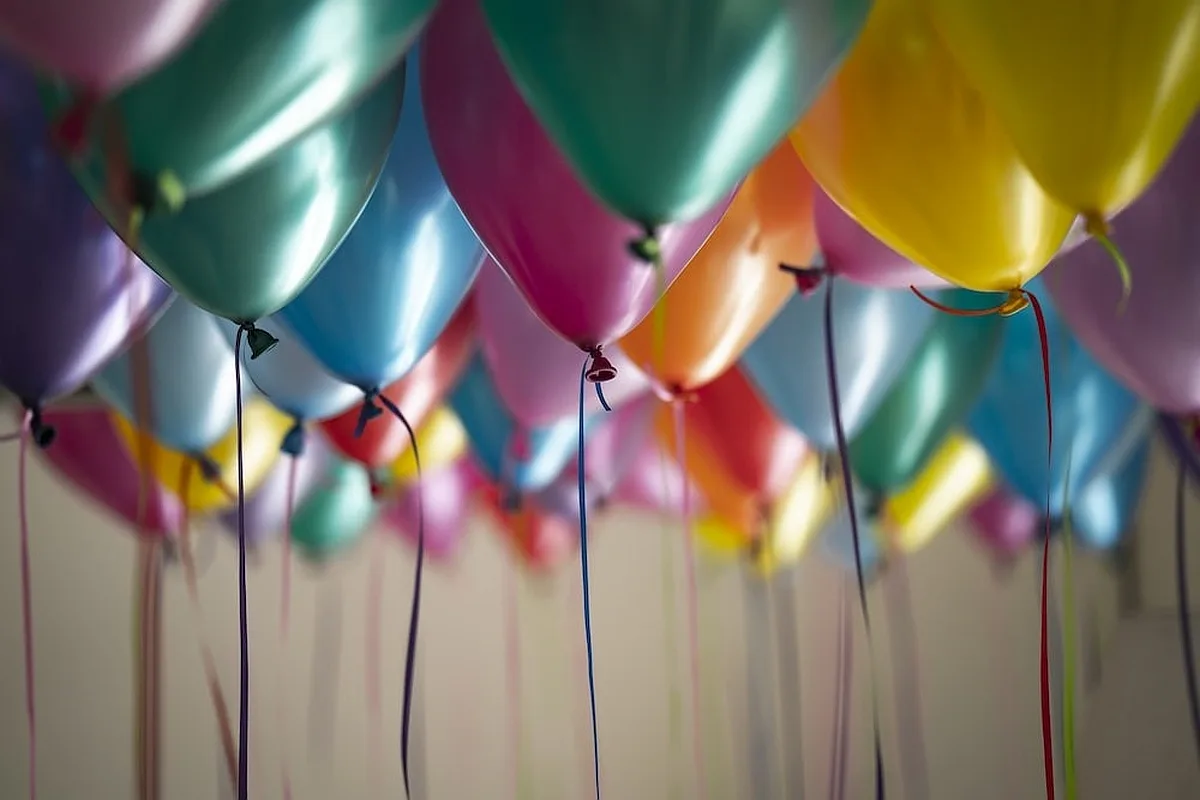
[[850, 290, 1004, 495]]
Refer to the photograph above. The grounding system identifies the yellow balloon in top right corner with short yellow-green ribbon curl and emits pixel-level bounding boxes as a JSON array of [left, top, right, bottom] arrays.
[[928, 0, 1200, 219]]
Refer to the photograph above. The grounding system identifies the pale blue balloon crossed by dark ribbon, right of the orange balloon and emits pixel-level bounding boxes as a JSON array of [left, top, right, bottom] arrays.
[[742, 279, 934, 450]]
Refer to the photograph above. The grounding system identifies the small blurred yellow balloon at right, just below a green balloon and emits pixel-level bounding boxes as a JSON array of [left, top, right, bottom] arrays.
[[880, 433, 992, 553]]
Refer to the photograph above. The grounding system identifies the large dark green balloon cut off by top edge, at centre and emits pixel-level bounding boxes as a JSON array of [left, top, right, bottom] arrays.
[[477, 0, 871, 225]]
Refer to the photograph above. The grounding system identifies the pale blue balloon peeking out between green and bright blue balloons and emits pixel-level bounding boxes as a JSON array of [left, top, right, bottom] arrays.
[[221, 315, 362, 422]]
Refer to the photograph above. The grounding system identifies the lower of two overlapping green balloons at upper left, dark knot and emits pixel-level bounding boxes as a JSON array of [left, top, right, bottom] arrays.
[[117, 65, 404, 323]]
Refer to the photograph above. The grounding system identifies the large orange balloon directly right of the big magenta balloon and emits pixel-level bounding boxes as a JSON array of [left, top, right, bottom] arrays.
[[620, 142, 816, 393]]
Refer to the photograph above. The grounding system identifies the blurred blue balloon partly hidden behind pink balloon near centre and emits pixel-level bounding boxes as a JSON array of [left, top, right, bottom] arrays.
[[450, 354, 594, 492]]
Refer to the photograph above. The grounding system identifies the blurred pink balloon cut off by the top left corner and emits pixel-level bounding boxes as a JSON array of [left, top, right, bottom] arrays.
[[0, 0, 221, 94]]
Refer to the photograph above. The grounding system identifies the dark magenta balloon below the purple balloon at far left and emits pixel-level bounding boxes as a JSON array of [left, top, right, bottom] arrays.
[[42, 405, 184, 536]]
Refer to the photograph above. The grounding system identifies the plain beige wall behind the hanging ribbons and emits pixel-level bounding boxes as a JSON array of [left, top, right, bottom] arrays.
[[0, 446, 1116, 800]]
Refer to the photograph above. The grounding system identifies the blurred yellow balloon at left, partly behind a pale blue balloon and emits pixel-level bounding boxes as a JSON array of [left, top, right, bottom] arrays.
[[109, 398, 292, 515]]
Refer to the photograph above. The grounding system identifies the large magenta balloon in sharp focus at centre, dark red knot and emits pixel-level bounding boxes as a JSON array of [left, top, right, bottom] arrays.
[[420, 0, 726, 349]]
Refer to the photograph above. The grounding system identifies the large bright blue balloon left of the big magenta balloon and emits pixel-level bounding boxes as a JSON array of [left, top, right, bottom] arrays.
[[280, 58, 482, 391]]
